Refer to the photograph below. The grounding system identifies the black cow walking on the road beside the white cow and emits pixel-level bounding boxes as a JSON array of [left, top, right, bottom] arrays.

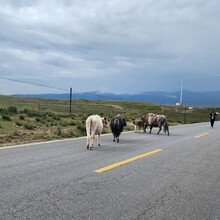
[[110, 114, 127, 143]]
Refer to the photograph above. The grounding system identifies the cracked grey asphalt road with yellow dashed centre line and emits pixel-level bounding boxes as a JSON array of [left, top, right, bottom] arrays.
[[0, 122, 220, 220]]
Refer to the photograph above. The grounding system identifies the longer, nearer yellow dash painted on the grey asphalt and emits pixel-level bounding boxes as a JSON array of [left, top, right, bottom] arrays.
[[95, 149, 162, 173]]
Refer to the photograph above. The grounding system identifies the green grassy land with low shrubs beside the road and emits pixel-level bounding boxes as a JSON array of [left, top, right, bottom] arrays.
[[0, 96, 220, 146]]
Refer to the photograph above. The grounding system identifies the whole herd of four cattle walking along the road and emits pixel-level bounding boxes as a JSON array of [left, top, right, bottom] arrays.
[[86, 113, 170, 150]]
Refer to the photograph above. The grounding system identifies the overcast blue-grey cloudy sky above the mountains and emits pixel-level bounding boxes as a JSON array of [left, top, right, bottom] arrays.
[[0, 0, 220, 94]]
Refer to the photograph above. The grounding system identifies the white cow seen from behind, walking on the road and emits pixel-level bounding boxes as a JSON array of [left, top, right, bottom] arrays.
[[86, 115, 108, 150]]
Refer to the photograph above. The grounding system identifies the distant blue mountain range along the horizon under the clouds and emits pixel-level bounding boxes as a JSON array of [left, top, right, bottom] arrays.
[[15, 90, 220, 107]]
